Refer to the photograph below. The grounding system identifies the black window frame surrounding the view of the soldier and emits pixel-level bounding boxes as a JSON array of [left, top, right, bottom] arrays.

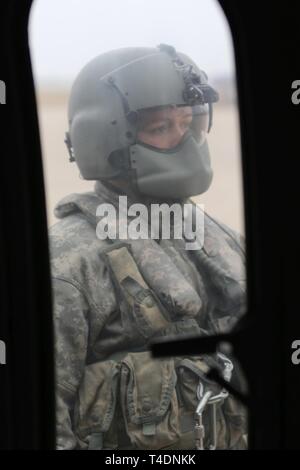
[[0, 0, 300, 449]]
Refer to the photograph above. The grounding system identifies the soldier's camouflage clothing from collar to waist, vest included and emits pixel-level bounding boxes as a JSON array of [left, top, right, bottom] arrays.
[[50, 182, 245, 449]]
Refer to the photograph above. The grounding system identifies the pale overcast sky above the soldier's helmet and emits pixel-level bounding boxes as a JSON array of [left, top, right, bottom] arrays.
[[29, 0, 234, 86]]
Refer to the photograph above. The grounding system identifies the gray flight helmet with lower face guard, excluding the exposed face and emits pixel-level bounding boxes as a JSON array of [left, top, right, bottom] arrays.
[[65, 45, 218, 197]]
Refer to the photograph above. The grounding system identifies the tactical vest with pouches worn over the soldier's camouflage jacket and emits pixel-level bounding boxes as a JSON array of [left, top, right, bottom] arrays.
[[52, 185, 246, 450]]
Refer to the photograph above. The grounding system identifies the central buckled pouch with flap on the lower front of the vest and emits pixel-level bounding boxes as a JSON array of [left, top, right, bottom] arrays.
[[120, 351, 180, 449]]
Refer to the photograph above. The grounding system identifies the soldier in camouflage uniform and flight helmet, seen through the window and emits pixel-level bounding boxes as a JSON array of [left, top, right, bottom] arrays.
[[50, 45, 246, 449]]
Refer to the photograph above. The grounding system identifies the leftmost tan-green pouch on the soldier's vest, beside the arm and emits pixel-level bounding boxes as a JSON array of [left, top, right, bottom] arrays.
[[74, 360, 119, 450]]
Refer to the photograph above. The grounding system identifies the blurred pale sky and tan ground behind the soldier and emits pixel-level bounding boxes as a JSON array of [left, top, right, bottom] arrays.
[[29, 0, 244, 233]]
